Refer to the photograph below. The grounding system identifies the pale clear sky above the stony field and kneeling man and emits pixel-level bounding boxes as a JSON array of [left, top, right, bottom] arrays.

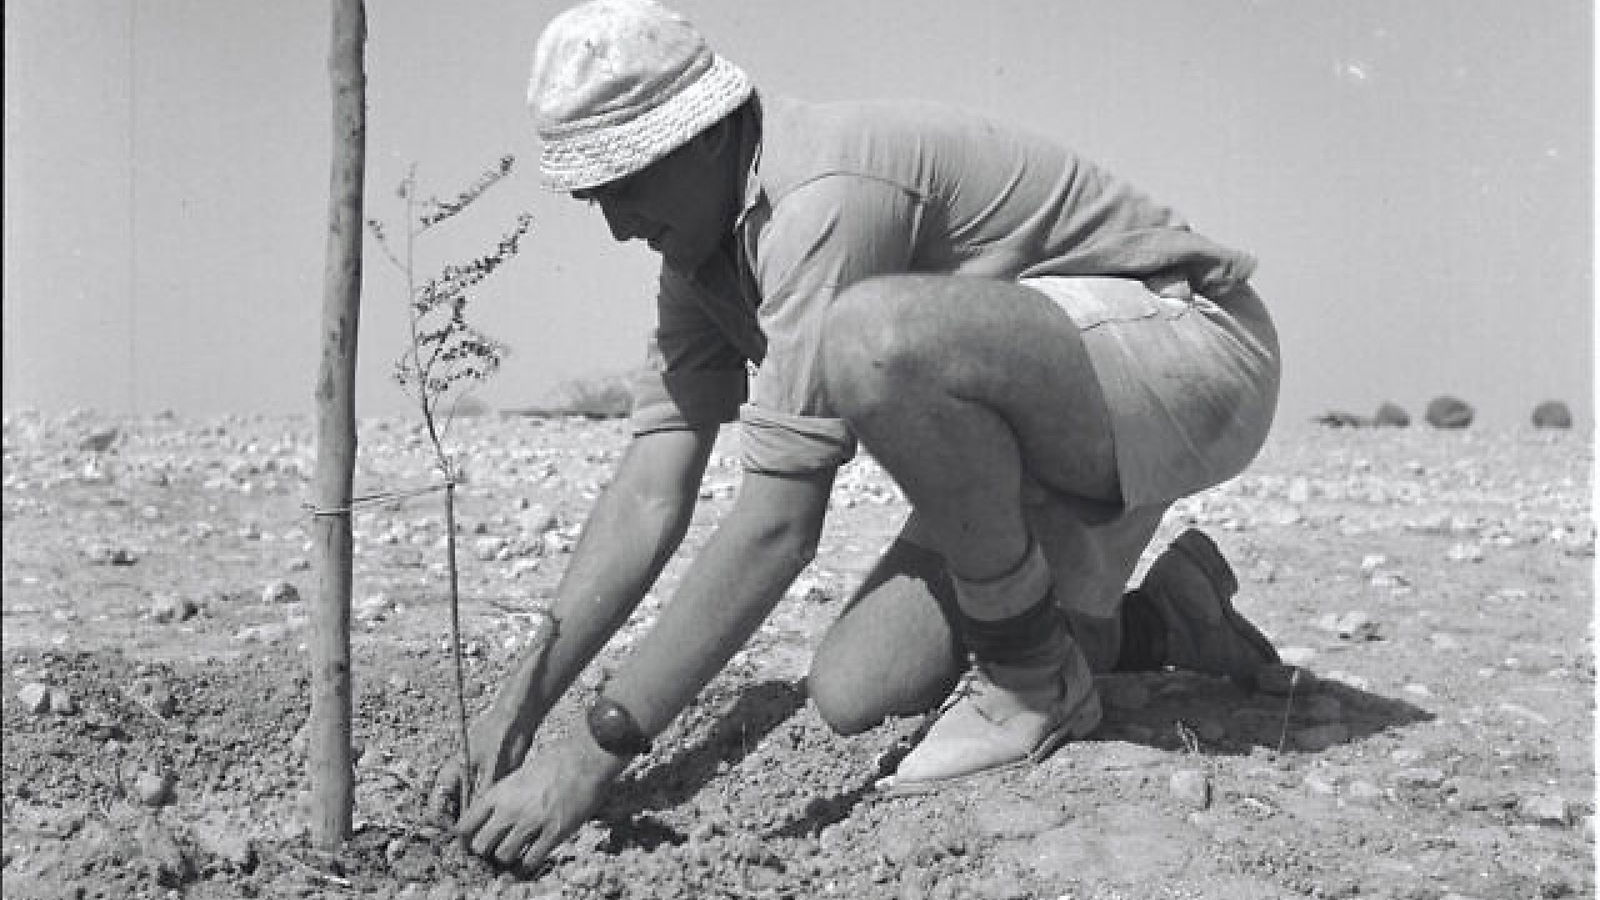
[[3, 0, 1595, 424]]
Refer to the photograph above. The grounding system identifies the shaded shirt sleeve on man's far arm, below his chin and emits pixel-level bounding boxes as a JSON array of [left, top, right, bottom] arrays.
[[630, 267, 747, 434]]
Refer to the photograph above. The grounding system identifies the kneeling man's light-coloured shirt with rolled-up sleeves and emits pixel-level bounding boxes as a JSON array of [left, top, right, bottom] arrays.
[[634, 98, 1254, 474]]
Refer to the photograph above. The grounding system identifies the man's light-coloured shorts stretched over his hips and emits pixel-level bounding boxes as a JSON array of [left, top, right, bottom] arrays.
[[1019, 275, 1278, 508]]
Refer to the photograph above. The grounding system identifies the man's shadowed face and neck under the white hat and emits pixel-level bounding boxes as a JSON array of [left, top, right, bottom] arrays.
[[573, 132, 734, 271]]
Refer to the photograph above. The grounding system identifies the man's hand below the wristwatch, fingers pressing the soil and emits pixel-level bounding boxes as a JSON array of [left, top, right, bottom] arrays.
[[456, 730, 627, 871]]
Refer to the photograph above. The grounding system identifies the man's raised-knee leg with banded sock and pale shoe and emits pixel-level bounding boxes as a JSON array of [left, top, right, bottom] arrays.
[[822, 275, 1120, 783]]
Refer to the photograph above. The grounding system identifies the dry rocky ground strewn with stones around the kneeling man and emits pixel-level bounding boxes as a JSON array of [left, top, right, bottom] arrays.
[[3, 412, 1595, 900]]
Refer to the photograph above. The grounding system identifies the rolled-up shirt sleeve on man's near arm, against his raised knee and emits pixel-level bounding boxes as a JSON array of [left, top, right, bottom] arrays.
[[739, 175, 923, 474]]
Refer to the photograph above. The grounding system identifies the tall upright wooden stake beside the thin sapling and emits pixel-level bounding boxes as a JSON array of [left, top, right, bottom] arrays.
[[307, 0, 366, 850]]
